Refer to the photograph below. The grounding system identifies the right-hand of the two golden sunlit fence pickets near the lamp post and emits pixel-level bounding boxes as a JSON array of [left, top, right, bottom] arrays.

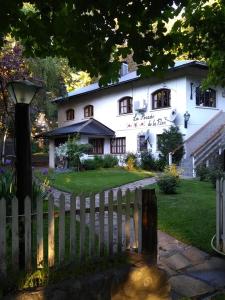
[[48, 195, 55, 267]]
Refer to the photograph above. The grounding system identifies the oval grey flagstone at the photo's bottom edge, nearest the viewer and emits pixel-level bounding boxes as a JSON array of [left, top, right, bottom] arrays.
[[169, 275, 214, 297]]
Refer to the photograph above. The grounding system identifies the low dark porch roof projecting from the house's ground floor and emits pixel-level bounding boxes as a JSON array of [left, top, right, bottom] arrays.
[[36, 119, 115, 138]]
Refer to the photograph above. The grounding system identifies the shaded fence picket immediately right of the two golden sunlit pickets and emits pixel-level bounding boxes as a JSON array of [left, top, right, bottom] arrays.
[[59, 193, 65, 263]]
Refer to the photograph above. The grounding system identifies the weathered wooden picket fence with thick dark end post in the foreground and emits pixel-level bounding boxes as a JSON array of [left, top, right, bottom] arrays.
[[0, 189, 157, 274]]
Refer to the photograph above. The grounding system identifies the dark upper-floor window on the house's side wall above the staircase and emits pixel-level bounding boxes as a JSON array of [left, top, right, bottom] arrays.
[[196, 87, 216, 107]]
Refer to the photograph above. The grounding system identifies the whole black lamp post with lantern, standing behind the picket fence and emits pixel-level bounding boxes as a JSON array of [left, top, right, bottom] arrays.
[[6, 79, 41, 268]]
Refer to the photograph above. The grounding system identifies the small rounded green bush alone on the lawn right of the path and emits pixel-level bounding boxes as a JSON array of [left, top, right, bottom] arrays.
[[157, 174, 179, 194]]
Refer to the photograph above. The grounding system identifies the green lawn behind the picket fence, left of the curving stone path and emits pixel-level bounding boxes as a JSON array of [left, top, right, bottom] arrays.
[[47, 168, 153, 194]]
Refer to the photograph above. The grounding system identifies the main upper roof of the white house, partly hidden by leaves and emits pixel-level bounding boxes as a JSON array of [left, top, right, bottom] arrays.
[[53, 60, 207, 103]]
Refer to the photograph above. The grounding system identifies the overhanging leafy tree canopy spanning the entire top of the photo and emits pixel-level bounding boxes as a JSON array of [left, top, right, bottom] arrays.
[[0, 0, 225, 85]]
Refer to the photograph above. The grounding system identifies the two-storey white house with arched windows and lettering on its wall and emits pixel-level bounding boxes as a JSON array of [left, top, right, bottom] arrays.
[[46, 61, 225, 175]]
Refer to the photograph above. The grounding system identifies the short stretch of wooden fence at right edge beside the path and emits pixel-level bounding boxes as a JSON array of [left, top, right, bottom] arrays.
[[216, 179, 225, 253]]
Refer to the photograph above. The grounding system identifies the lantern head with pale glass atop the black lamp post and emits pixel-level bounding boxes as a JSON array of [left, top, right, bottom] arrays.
[[6, 79, 41, 104]]
